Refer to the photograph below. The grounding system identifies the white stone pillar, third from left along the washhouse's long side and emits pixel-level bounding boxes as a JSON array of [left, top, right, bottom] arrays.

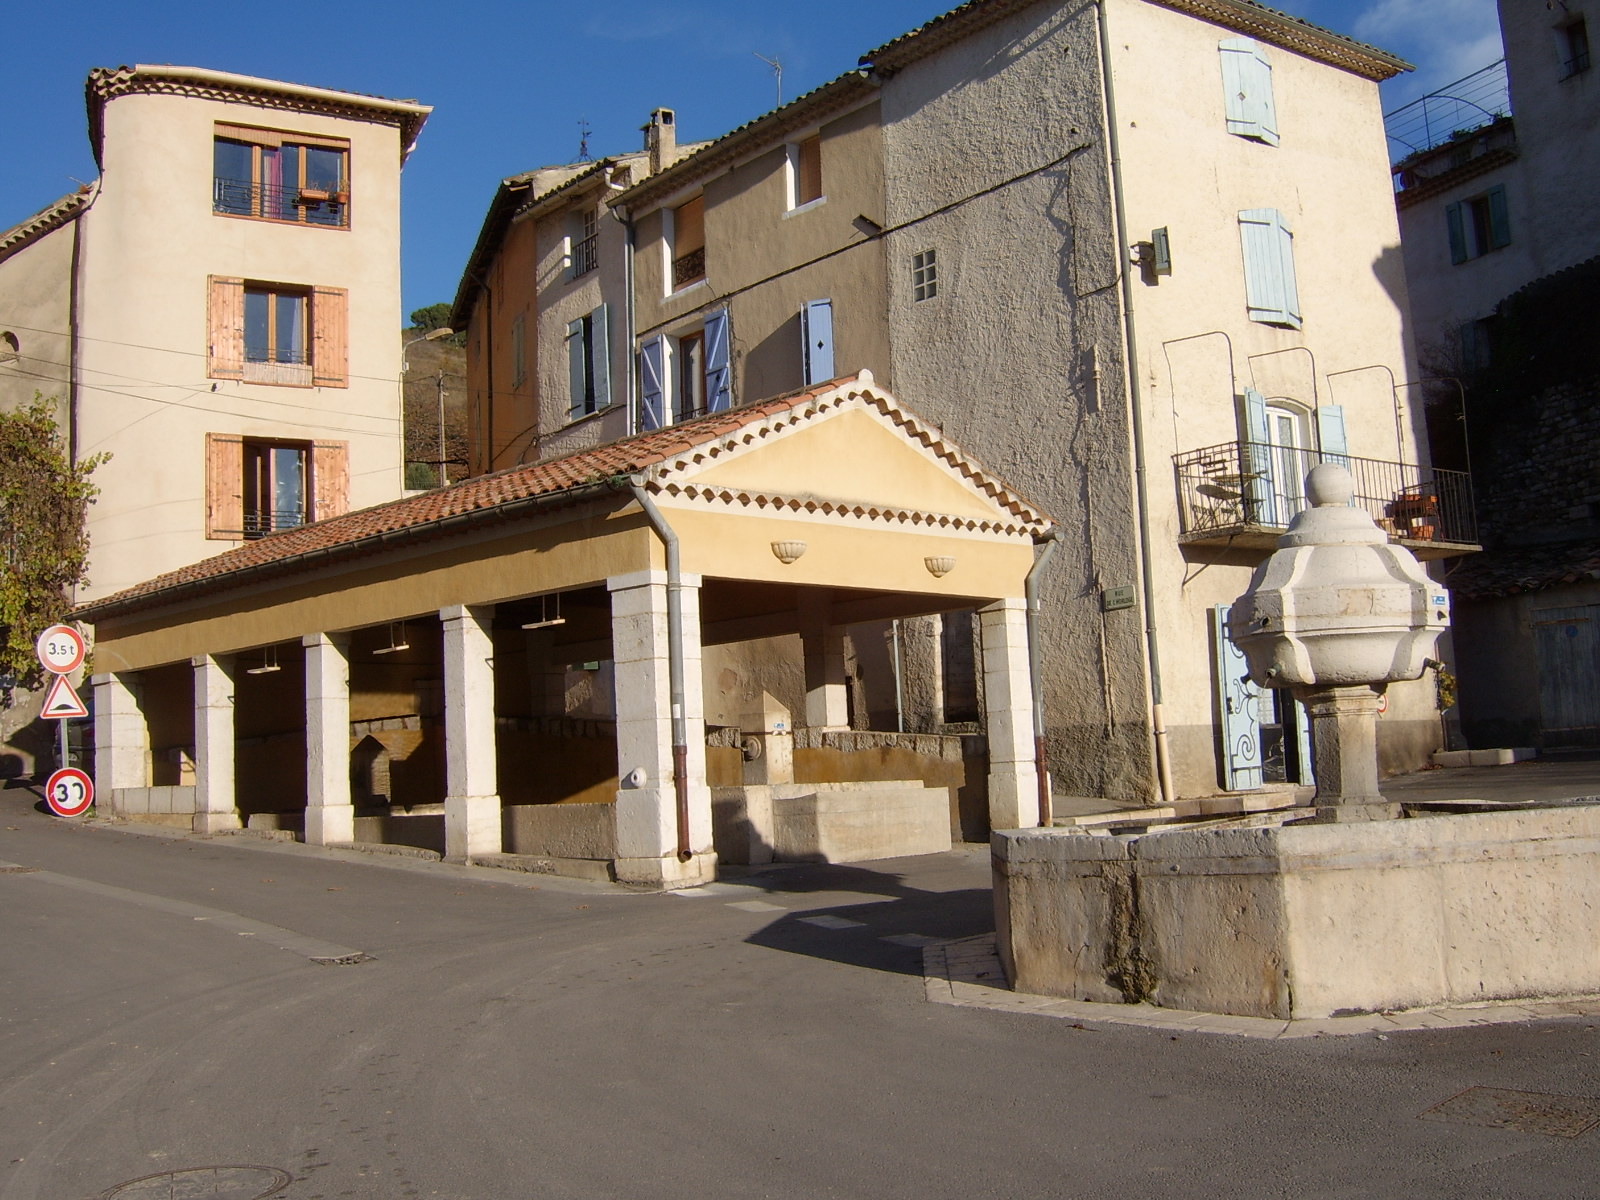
[[301, 634, 355, 846]]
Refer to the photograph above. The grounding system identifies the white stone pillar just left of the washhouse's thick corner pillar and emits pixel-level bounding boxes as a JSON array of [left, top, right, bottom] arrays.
[[438, 605, 504, 861]]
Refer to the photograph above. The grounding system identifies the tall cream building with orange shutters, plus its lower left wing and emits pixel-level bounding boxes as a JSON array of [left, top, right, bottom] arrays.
[[0, 66, 430, 602]]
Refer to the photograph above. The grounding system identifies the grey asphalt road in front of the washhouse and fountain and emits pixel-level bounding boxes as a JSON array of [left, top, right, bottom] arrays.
[[0, 790, 1600, 1200]]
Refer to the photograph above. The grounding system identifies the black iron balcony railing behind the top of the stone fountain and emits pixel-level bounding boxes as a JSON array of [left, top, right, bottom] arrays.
[[1173, 442, 1478, 558]]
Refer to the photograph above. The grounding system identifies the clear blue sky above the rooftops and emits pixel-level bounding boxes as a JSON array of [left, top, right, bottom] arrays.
[[0, 0, 1497, 314]]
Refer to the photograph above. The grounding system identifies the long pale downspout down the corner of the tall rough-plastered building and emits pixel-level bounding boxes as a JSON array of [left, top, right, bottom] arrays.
[[1094, 0, 1174, 805]]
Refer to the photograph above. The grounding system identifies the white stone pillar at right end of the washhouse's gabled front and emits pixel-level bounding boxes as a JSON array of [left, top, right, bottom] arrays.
[[979, 597, 1038, 829]]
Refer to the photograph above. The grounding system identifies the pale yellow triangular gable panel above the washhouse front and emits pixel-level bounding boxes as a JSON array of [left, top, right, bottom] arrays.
[[685, 408, 1014, 520]]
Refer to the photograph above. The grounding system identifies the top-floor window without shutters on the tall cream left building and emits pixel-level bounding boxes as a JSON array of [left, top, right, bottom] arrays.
[[211, 125, 350, 229]]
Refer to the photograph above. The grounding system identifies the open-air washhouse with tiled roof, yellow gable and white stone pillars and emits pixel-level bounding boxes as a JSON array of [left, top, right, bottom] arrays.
[[75, 373, 1050, 888]]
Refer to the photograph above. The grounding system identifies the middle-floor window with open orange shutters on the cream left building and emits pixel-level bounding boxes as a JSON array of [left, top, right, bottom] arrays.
[[206, 275, 349, 387]]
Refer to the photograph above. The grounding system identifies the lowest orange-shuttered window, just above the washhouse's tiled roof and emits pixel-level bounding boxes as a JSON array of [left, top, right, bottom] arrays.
[[205, 434, 350, 541]]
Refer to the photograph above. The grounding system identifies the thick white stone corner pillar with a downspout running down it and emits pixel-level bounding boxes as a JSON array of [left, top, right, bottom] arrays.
[[606, 571, 717, 888]]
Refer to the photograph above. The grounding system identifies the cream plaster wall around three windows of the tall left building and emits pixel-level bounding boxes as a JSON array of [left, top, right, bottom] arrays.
[[78, 86, 402, 598]]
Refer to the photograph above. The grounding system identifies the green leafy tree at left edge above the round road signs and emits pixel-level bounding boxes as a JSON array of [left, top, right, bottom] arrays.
[[0, 394, 110, 688]]
